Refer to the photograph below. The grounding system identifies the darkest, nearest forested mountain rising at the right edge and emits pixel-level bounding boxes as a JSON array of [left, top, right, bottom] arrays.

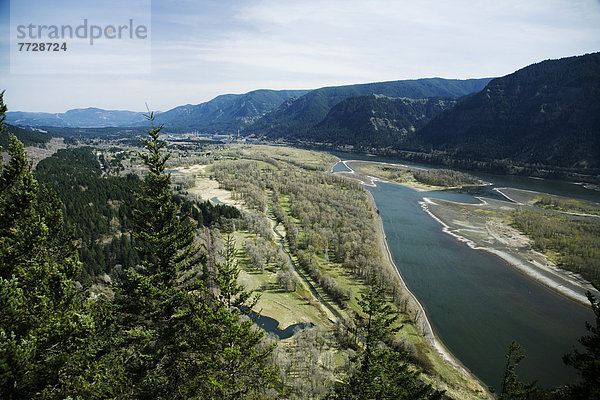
[[417, 53, 600, 170]]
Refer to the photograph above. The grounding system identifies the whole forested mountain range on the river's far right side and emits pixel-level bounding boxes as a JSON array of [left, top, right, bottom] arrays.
[[245, 53, 600, 179]]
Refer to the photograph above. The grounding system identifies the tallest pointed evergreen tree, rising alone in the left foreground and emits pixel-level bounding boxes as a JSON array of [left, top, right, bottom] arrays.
[[115, 110, 205, 398]]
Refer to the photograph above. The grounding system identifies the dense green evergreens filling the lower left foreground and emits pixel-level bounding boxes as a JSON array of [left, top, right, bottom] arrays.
[[0, 97, 282, 399]]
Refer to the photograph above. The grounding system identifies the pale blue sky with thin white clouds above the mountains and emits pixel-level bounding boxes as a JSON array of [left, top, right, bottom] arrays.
[[0, 0, 600, 112]]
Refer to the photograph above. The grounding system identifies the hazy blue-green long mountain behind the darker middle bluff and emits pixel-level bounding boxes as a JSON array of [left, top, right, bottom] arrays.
[[244, 78, 490, 139]]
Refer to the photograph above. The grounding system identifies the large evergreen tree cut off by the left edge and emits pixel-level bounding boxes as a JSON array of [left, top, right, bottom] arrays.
[[0, 93, 93, 399]]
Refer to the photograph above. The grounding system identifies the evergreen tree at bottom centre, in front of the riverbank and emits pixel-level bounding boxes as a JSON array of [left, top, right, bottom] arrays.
[[330, 285, 443, 400]]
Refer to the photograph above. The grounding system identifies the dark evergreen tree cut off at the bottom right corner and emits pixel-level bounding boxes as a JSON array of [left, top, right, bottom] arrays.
[[563, 291, 600, 399]]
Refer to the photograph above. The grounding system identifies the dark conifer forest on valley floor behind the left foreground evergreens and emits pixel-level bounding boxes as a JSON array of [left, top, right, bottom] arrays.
[[35, 147, 240, 282]]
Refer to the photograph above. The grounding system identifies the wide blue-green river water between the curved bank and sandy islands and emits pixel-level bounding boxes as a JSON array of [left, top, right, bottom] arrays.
[[330, 158, 596, 387]]
